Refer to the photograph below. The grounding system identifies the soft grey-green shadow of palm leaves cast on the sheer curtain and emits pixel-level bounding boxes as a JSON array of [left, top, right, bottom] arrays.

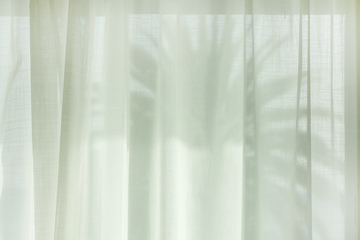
[[131, 13, 342, 240]]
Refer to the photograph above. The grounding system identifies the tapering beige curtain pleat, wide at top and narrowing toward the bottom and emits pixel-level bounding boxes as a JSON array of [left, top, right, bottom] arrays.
[[29, 1, 67, 239]]
